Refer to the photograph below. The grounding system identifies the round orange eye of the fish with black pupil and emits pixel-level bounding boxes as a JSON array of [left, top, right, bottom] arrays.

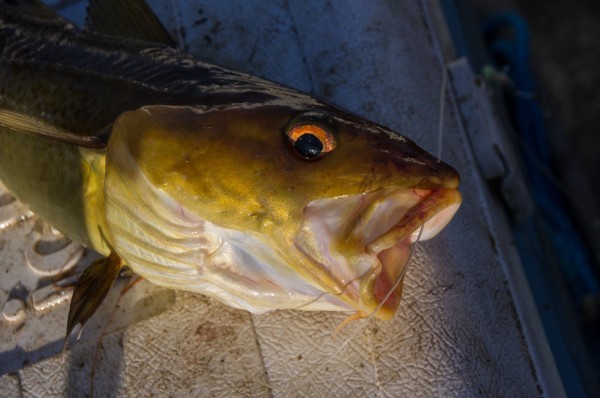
[[286, 114, 336, 160]]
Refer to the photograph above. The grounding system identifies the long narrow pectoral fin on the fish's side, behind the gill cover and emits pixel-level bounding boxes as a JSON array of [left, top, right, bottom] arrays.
[[0, 109, 107, 148]]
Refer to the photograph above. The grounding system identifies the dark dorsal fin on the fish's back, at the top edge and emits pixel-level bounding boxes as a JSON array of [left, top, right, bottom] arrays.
[[85, 0, 177, 47]]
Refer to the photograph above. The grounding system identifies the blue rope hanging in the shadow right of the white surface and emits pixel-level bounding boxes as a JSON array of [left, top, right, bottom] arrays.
[[485, 13, 600, 299]]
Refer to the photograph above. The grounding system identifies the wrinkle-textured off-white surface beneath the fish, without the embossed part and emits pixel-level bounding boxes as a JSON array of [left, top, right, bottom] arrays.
[[0, 0, 560, 397]]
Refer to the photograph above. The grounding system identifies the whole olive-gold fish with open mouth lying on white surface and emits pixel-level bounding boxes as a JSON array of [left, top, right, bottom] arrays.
[[0, 0, 462, 337]]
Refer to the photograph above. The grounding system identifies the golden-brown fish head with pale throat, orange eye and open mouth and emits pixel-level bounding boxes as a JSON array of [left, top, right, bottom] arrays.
[[106, 104, 461, 319]]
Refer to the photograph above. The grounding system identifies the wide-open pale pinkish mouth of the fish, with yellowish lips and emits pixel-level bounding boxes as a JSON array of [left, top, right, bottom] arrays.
[[296, 188, 462, 319]]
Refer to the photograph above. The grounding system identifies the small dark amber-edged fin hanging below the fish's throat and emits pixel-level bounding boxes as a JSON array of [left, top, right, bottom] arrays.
[[66, 252, 123, 339]]
